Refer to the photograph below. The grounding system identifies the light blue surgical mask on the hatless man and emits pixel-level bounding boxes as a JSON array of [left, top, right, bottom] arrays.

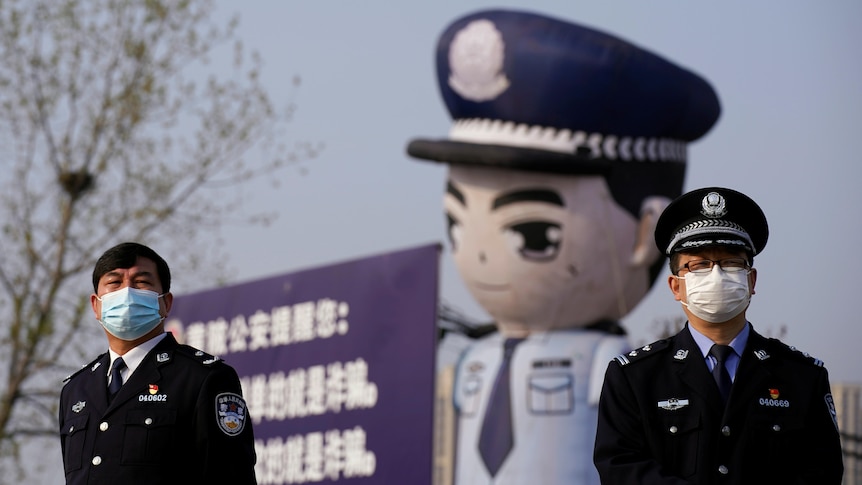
[[96, 287, 164, 340]]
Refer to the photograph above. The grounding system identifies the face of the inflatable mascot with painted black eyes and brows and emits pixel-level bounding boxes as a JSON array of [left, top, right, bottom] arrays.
[[444, 165, 651, 336]]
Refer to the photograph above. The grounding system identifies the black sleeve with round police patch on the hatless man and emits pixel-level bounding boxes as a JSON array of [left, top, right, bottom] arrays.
[[195, 364, 257, 485]]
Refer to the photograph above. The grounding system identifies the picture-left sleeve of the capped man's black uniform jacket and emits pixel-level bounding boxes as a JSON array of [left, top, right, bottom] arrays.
[[593, 361, 692, 485]]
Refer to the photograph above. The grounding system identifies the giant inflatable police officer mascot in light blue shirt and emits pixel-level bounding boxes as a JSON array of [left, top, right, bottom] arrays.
[[407, 10, 720, 485]]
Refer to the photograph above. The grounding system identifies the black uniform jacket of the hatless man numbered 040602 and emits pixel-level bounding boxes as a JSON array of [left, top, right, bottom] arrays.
[[60, 334, 257, 485]]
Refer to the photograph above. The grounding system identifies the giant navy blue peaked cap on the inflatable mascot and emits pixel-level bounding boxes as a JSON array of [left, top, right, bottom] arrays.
[[407, 10, 721, 213]]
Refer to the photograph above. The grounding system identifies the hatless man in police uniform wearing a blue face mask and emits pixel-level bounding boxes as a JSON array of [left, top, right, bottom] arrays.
[[60, 243, 256, 485]]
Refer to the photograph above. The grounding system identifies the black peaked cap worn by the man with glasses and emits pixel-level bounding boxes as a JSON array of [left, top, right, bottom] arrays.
[[655, 187, 769, 256]]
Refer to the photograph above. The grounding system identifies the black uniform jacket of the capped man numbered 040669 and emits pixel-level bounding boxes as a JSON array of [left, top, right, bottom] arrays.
[[594, 327, 843, 485]]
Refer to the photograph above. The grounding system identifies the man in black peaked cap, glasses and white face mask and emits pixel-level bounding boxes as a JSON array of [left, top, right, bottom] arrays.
[[594, 187, 843, 485]]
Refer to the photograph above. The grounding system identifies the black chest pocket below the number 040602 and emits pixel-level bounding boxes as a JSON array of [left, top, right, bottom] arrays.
[[121, 409, 180, 465]]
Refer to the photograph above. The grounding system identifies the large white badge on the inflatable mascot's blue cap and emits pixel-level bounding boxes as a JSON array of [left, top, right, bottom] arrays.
[[449, 19, 509, 102]]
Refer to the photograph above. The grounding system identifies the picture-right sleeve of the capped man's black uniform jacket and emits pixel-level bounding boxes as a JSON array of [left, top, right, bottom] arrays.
[[801, 368, 844, 485]]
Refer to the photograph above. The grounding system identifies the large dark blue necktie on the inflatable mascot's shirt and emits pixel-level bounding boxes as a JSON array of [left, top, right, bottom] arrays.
[[479, 338, 524, 476]]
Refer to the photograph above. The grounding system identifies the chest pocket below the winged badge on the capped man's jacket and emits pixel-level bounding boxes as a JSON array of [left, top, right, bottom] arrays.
[[659, 414, 702, 477]]
